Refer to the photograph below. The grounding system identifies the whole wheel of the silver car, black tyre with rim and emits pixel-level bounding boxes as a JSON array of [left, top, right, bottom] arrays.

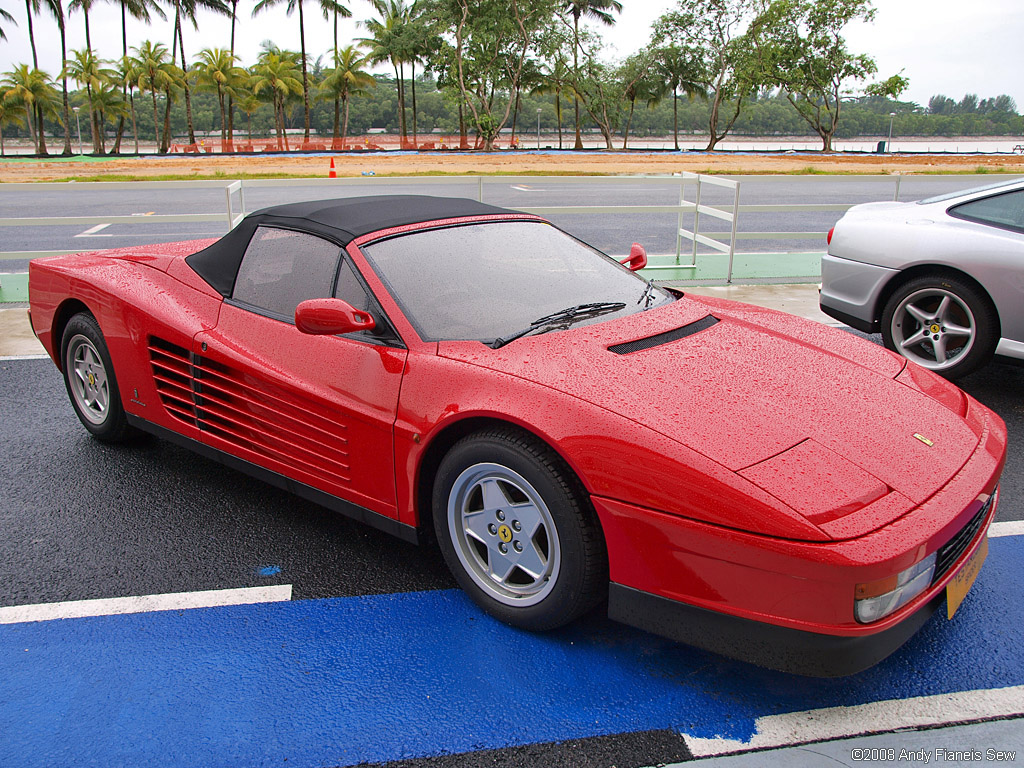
[[882, 274, 999, 379]]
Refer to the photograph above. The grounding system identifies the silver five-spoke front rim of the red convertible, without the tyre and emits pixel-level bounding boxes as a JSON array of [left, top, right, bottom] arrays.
[[447, 463, 561, 606]]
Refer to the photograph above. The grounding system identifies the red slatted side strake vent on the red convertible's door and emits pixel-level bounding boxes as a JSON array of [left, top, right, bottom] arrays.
[[148, 337, 351, 482]]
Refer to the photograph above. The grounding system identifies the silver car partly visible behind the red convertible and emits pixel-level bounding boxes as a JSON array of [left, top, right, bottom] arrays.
[[820, 179, 1024, 379]]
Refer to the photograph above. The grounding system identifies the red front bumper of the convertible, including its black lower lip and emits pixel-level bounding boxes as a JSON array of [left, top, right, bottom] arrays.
[[594, 403, 1006, 677]]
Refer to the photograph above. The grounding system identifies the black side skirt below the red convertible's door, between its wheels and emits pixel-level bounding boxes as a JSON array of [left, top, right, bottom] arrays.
[[126, 414, 419, 544]]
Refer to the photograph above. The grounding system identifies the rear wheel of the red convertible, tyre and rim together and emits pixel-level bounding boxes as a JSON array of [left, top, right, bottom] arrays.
[[60, 312, 131, 442]]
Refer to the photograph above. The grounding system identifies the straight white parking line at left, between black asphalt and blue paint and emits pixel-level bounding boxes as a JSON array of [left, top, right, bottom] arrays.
[[0, 584, 292, 624]]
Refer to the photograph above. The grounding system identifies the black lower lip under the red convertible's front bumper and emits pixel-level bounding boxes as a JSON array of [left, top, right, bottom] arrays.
[[608, 584, 945, 677]]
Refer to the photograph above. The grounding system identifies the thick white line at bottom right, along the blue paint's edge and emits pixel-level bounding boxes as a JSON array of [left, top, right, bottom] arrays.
[[670, 685, 1024, 768]]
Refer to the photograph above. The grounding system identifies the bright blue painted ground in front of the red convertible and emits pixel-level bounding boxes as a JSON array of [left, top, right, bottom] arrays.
[[0, 536, 1024, 768]]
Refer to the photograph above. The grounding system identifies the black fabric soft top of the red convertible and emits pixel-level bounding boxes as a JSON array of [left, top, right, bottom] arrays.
[[185, 195, 518, 296]]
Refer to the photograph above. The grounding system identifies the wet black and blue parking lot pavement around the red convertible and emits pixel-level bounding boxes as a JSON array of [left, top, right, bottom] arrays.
[[0, 287, 1024, 768]]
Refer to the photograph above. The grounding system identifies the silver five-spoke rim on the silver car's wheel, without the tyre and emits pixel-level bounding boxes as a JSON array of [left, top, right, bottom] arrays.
[[890, 288, 978, 371]]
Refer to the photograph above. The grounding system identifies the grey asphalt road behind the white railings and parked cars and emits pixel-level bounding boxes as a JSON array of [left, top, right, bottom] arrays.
[[0, 176, 1015, 272]]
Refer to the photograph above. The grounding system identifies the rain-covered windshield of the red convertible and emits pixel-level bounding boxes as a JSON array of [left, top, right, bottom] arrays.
[[362, 221, 674, 342]]
